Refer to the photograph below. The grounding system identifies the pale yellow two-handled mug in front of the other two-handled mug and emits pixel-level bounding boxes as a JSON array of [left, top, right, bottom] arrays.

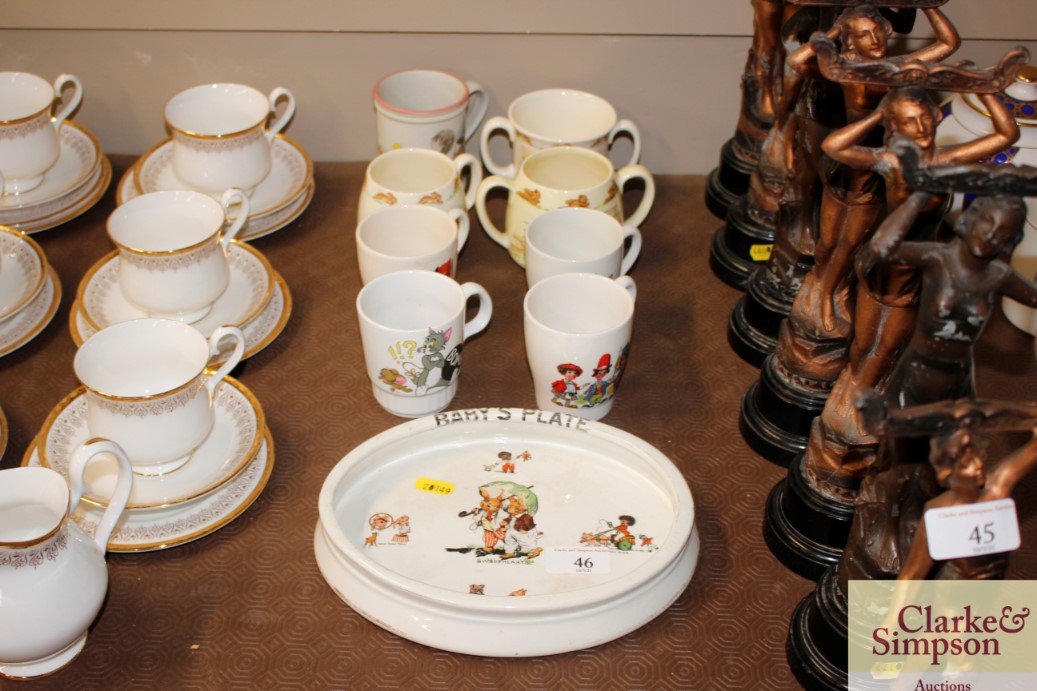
[[475, 146, 655, 267]]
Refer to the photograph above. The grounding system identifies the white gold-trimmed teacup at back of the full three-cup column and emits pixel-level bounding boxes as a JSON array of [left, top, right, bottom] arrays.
[[166, 83, 296, 194]]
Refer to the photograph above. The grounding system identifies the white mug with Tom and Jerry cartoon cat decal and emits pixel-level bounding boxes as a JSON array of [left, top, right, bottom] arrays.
[[357, 271, 494, 417]]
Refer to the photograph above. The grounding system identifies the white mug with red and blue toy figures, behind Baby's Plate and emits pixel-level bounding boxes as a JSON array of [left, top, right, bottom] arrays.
[[523, 274, 637, 420]]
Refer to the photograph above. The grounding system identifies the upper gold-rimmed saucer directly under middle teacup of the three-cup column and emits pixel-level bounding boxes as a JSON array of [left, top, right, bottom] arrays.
[[76, 241, 274, 338]]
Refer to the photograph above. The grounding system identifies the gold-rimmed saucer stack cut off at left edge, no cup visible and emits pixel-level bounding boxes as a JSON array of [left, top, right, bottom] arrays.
[[0, 225, 61, 357]]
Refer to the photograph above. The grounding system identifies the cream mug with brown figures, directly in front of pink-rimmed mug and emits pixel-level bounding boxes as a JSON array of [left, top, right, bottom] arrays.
[[357, 148, 482, 221]]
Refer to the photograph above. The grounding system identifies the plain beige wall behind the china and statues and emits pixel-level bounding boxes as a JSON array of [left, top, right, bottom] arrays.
[[0, 0, 1037, 173]]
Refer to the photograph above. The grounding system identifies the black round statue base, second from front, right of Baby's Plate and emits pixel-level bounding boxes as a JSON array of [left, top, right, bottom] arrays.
[[763, 453, 853, 580]]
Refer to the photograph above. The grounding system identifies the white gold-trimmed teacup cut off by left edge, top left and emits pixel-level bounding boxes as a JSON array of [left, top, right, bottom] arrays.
[[0, 72, 83, 194]]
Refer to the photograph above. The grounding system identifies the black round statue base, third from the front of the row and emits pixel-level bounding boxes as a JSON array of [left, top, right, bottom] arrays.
[[738, 354, 828, 467]]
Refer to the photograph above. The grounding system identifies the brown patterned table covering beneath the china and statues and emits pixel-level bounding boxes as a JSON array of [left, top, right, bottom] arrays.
[[0, 156, 1037, 689]]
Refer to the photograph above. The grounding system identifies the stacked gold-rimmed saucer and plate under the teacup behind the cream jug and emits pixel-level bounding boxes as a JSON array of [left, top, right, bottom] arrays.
[[22, 377, 274, 552]]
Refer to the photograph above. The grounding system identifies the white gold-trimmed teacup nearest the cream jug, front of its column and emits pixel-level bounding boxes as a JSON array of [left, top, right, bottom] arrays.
[[74, 319, 245, 475]]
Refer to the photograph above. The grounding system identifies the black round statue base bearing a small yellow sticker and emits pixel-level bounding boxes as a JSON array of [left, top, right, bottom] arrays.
[[709, 197, 775, 289]]
